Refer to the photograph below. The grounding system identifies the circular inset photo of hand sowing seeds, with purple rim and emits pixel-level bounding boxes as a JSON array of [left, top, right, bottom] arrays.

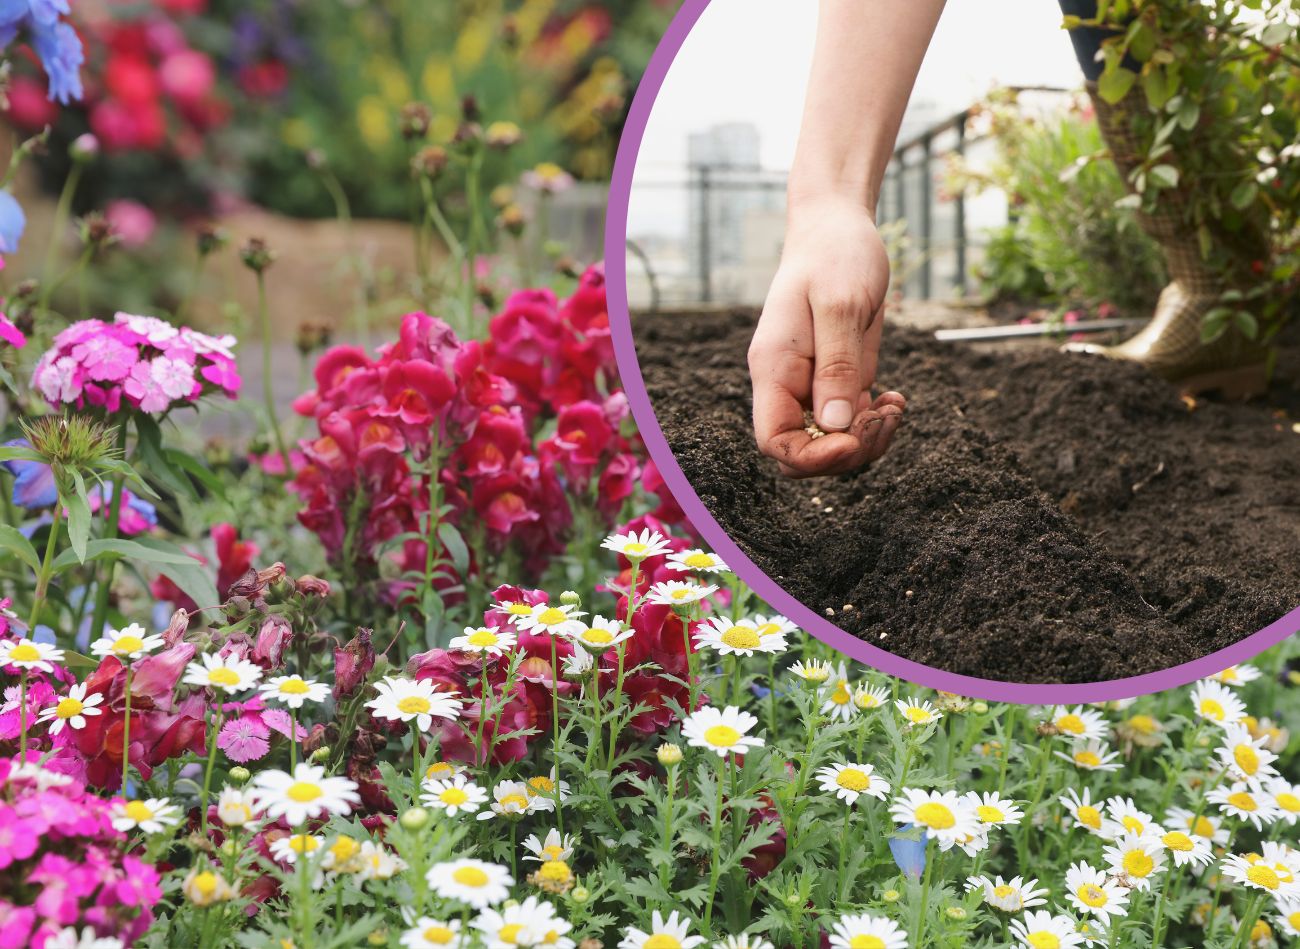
[[607, 0, 1300, 698]]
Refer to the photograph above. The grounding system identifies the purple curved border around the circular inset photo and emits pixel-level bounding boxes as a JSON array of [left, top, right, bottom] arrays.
[[605, 0, 1300, 705]]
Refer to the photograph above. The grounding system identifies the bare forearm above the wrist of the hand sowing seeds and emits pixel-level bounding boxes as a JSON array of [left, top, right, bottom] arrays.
[[789, 0, 944, 216]]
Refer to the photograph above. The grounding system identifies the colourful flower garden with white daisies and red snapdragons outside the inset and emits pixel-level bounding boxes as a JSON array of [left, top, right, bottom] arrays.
[[0, 0, 1300, 949]]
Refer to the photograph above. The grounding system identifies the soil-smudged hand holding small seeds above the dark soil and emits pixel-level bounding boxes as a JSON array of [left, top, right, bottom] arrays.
[[749, 198, 907, 478]]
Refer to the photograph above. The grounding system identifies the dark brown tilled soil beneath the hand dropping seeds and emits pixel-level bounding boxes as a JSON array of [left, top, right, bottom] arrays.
[[636, 312, 1300, 683]]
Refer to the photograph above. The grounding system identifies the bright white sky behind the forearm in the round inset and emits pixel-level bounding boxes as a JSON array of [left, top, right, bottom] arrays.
[[629, 0, 1082, 234]]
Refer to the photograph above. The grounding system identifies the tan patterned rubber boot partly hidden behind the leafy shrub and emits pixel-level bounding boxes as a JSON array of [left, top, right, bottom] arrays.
[[1065, 77, 1268, 399]]
